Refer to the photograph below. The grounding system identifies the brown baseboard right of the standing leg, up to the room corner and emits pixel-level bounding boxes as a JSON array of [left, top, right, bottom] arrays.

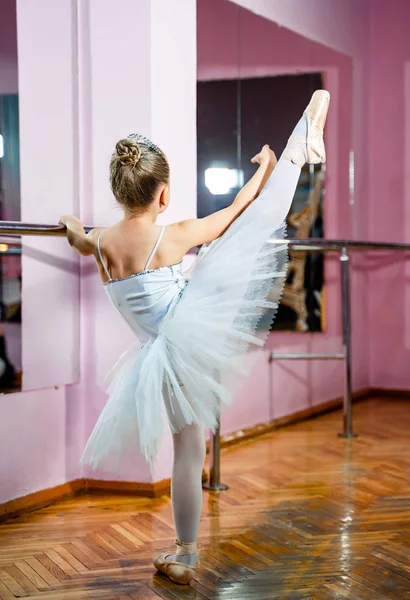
[[216, 388, 373, 450]]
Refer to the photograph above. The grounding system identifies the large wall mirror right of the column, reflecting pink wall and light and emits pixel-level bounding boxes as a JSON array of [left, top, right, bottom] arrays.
[[197, 0, 352, 332]]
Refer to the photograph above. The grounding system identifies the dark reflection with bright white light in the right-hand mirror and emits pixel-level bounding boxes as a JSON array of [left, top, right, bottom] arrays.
[[198, 73, 323, 331]]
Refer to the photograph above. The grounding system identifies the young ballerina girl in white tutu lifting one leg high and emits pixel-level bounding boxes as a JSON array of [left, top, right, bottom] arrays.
[[61, 90, 329, 584]]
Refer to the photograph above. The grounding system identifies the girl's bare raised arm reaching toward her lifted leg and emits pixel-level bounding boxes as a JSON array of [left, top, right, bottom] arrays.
[[174, 145, 277, 251]]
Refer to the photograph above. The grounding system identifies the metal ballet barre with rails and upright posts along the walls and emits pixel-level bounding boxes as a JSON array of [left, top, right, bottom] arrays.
[[0, 221, 410, 491]]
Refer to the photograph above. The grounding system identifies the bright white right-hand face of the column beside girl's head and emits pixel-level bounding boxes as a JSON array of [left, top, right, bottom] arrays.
[[150, 0, 197, 223]]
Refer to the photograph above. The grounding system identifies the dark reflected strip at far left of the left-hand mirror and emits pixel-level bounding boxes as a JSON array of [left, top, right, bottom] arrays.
[[0, 0, 22, 394]]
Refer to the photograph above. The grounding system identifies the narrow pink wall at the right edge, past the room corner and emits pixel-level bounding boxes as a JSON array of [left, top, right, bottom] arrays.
[[368, 0, 410, 389]]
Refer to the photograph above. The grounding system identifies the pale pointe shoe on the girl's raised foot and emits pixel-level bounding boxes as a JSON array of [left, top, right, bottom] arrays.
[[282, 90, 330, 168]]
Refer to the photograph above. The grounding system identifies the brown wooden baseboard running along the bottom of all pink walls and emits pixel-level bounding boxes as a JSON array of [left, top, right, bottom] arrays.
[[0, 388, 404, 522]]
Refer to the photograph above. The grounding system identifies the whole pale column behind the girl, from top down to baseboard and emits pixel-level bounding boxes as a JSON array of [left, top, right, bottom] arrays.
[[77, 0, 196, 481]]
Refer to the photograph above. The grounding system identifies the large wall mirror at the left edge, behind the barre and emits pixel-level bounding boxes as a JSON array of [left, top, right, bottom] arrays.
[[0, 0, 80, 394]]
